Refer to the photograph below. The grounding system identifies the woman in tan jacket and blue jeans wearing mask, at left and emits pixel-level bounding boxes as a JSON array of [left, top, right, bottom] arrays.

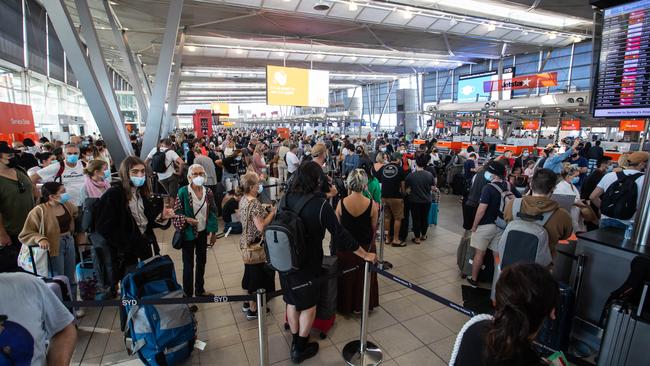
[[18, 182, 83, 317]]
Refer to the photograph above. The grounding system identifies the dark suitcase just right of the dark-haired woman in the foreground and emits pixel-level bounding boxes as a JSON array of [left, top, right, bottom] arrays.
[[537, 282, 575, 352]]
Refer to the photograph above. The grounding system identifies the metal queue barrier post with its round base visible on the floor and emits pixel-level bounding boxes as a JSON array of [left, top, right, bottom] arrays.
[[343, 262, 384, 366]]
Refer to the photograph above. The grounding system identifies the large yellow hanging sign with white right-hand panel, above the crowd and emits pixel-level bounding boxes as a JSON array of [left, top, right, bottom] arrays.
[[266, 65, 329, 107]]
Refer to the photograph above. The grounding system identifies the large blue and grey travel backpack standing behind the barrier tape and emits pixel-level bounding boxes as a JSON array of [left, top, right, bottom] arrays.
[[120, 255, 196, 365]]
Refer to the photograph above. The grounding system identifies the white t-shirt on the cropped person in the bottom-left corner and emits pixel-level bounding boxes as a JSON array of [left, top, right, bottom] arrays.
[[0, 273, 74, 366]]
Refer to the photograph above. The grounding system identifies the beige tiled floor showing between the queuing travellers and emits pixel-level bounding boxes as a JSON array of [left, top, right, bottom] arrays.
[[73, 196, 467, 366]]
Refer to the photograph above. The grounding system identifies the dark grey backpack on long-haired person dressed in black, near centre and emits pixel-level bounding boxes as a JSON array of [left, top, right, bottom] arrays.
[[264, 194, 314, 274]]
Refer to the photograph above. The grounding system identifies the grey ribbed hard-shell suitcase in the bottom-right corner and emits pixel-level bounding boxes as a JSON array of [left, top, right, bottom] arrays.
[[598, 283, 650, 366]]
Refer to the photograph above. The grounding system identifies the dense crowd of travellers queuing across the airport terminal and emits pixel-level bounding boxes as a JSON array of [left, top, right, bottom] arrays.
[[0, 129, 648, 365]]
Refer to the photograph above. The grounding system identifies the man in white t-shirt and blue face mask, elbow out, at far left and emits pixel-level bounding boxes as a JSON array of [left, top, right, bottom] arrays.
[[31, 145, 85, 207]]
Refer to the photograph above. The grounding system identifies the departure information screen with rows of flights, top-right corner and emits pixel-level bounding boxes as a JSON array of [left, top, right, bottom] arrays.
[[594, 0, 650, 118]]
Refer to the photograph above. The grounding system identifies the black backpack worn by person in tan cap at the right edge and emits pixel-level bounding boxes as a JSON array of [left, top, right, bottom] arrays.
[[600, 172, 643, 220]]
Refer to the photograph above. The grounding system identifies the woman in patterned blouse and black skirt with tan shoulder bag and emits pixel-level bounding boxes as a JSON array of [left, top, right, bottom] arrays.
[[239, 172, 275, 320]]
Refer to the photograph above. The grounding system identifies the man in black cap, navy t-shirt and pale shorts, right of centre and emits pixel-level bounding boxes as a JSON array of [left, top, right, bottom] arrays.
[[467, 160, 521, 287]]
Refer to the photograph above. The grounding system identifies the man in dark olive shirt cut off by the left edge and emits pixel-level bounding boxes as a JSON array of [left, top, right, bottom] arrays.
[[0, 142, 37, 269]]
